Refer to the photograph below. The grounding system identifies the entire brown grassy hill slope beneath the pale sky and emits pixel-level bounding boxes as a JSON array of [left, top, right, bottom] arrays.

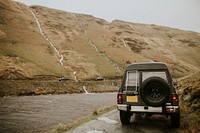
[[0, 0, 200, 80]]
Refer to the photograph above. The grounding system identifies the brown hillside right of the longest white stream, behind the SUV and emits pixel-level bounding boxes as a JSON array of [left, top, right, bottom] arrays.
[[31, 6, 200, 79]]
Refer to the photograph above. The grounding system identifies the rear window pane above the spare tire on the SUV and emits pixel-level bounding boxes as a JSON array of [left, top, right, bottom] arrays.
[[142, 71, 168, 82]]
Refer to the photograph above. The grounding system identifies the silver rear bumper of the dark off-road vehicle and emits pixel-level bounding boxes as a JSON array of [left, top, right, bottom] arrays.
[[117, 104, 180, 113]]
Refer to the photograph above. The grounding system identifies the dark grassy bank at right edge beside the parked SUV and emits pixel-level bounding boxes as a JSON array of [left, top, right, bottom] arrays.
[[177, 72, 200, 133]]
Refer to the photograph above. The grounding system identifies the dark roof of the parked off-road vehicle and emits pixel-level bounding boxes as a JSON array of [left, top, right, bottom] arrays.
[[126, 62, 168, 71]]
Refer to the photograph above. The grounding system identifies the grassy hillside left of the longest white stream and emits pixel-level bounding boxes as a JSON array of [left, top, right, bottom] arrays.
[[0, 0, 67, 79]]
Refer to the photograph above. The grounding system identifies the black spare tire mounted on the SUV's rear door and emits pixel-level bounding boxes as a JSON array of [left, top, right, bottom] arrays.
[[140, 77, 170, 107]]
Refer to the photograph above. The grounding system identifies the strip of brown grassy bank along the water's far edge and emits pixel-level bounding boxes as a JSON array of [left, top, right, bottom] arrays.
[[0, 77, 119, 97]]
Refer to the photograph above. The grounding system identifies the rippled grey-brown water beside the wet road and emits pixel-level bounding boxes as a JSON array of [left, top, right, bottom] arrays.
[[0, 93, 116, 133]]
